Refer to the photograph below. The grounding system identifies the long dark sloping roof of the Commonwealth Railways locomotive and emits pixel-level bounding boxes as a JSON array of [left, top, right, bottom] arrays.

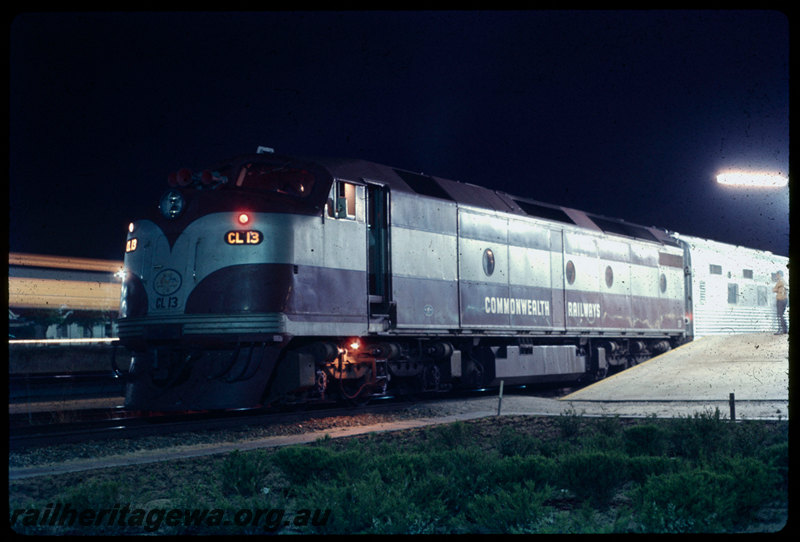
[[231, 154, 678, 246]]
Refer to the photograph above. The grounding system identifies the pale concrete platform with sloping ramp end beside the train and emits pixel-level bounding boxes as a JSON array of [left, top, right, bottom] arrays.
[[561, 333, 789, 419]]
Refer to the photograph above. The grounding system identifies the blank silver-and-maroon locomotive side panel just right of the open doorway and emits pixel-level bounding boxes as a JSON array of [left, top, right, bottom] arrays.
[[391, 192, 458, 330]]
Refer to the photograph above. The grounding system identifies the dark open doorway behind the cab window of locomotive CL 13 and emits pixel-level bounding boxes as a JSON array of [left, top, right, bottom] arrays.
[[367, 184, 395, 330]]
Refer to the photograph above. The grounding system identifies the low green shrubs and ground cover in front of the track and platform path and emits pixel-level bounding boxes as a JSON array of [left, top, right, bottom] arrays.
[[9, 411, 789, 534]]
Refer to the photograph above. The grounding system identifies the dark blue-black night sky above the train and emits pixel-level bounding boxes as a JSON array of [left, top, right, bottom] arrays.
[[9, 10, 789, 260]]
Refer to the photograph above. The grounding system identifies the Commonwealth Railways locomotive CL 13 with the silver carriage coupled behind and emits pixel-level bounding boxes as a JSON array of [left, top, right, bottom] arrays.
[[118, 152, 788, 410]]
